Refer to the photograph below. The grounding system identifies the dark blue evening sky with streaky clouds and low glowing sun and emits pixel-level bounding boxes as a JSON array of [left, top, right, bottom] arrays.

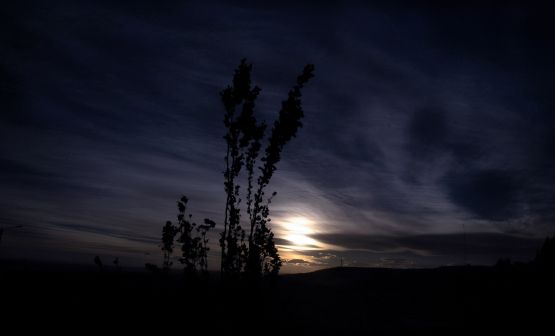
[[0, 1, 555, 272]]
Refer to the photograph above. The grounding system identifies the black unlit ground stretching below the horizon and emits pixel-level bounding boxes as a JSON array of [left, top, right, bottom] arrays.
[[0, 266, 555, 335]]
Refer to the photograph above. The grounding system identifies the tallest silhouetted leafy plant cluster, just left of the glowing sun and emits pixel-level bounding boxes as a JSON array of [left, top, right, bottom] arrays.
[[220, 59, 314, 275]]
